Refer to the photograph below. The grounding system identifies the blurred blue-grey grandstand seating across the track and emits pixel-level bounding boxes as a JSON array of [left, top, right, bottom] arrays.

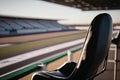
[[0, 17, 75, 37]]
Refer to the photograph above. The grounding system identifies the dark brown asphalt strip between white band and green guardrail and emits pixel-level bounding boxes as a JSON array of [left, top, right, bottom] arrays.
[[0, 44, 83, 75]]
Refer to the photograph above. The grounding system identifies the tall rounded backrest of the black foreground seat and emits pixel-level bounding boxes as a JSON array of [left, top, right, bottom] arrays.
[[77, 13, 112, 80]]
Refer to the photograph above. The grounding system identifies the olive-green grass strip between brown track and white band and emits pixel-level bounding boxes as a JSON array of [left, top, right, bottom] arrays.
[[0, 33, 85, 56]]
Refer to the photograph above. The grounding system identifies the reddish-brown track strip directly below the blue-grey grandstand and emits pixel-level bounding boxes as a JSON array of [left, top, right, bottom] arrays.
[[0, 30, 86, 44]]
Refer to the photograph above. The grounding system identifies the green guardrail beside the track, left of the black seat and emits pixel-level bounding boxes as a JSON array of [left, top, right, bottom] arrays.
[[0, 45, 82, 80]]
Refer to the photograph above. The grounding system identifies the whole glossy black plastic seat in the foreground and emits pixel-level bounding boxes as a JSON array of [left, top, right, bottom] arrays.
[[32, 13, 112, 80]]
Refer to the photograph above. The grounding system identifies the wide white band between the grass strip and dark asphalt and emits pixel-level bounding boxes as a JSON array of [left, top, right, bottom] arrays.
[[0, 38, 85, 68]]
